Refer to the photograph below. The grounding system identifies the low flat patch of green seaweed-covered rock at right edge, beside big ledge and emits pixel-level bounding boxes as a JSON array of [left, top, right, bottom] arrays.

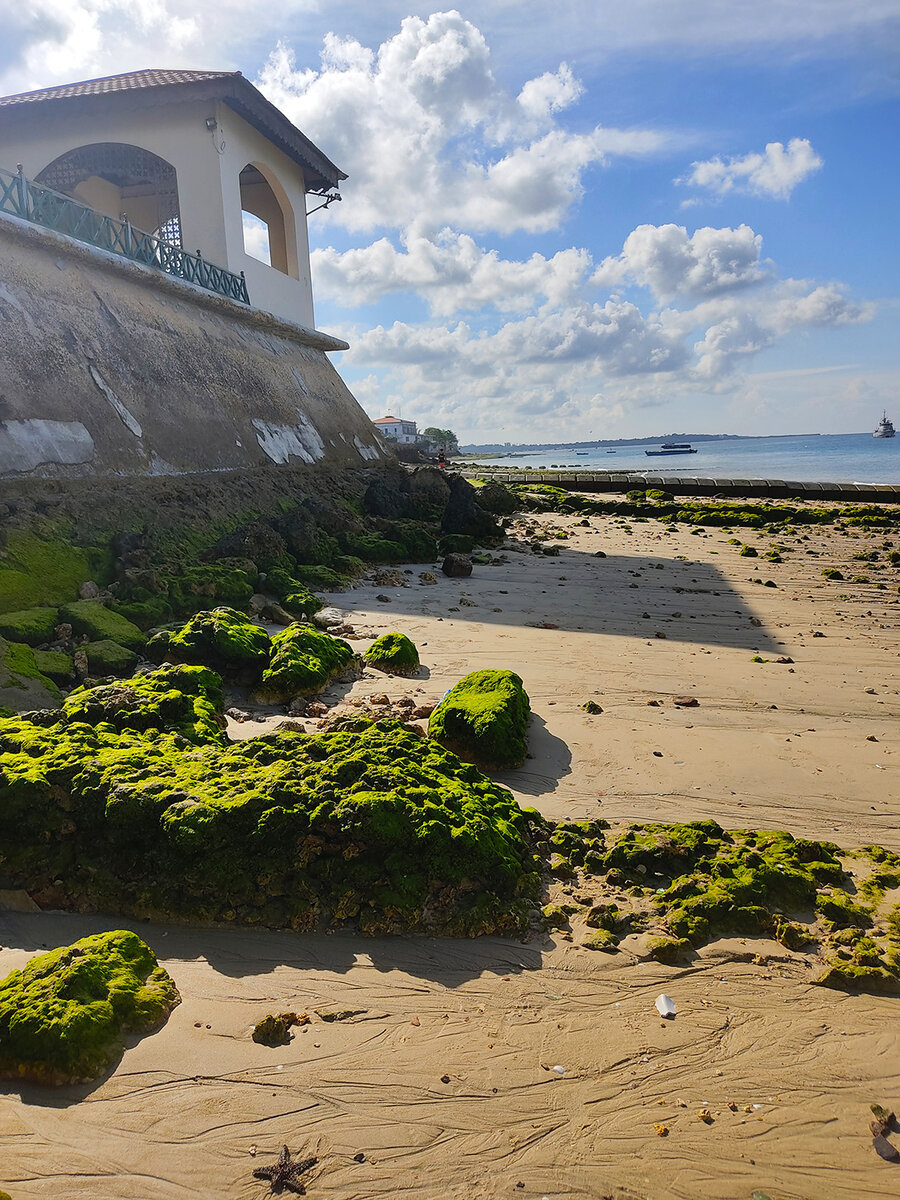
[[538, 821, 900, 994]]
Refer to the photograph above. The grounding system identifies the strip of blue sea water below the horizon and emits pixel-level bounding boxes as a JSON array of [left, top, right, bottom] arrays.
[[464, 433, 900, 485]]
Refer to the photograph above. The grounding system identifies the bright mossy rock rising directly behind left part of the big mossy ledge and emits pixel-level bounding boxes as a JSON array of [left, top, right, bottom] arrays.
[[62, 666, 226, 745]]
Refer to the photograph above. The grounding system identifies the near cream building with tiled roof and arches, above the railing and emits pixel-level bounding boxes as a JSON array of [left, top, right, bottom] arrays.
[[0, 71, 347, 329]]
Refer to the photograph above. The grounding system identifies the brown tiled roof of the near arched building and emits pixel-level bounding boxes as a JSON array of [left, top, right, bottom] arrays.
[[0, 71, 347, 194]]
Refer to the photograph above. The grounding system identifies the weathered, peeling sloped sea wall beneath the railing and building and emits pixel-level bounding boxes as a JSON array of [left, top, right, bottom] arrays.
[[0, 211, 391, 479]]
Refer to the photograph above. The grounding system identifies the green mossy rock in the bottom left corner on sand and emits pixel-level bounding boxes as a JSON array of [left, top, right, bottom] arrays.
[[0, 929, 181, 1084]]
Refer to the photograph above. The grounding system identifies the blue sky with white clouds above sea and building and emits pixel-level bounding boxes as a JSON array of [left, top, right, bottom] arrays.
[[0, 0, 900, 442]]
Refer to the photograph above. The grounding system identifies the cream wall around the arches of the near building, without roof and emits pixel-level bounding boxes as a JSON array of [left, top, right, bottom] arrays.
[[0, 90, 314, 329]]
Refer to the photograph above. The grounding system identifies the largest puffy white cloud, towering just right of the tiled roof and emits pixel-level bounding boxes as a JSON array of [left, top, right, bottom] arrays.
[[257, 11, 665, 234]]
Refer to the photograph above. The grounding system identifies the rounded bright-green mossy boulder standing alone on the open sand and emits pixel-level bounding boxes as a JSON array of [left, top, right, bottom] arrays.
[[428, 671, 530, 767]]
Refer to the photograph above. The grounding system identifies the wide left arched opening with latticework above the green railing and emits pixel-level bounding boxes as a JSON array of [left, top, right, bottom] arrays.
[[36, 142, 181, 246]]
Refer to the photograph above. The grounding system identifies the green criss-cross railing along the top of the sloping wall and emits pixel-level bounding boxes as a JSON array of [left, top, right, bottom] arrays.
[[0, 168, 250, 305]]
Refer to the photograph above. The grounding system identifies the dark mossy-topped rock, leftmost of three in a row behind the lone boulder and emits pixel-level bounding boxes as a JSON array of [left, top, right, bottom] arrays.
[[149, 608, 271, 677]]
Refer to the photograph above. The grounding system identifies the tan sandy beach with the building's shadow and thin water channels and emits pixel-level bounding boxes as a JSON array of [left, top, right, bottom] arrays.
[[0, 501, 900, 1200]]
